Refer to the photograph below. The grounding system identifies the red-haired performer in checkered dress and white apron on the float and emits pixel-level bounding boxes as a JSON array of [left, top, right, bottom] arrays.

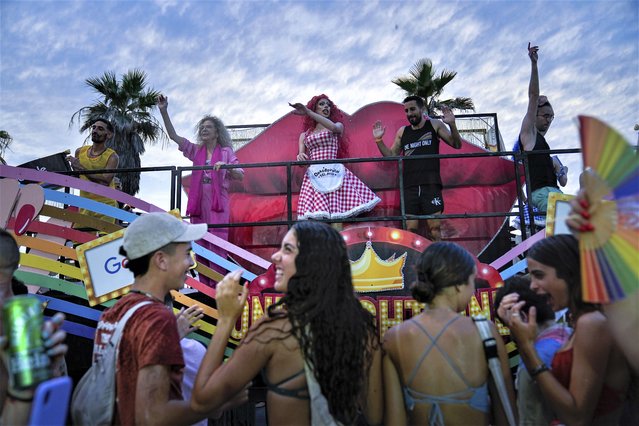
[[289, 95, 381, 219]]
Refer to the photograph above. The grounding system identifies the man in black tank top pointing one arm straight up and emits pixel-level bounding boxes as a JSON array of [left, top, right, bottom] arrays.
[[519, 43, 568, 211]]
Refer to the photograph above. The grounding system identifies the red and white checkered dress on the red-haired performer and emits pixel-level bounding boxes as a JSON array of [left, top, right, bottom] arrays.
[[297, 130, 381, 219]]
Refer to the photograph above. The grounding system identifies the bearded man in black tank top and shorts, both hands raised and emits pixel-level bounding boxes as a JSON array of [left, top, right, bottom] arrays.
[[373, 96, 461, 241]]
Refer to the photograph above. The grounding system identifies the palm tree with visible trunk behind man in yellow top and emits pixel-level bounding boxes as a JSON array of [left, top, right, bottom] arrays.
[[69, 69, 166, 195]]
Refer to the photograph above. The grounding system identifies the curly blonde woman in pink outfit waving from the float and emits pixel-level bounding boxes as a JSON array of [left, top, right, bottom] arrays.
[[157, 95, 244, 287]]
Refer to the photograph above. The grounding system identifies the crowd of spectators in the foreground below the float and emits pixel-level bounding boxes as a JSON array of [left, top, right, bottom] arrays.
[[0, 213, 637, 425]]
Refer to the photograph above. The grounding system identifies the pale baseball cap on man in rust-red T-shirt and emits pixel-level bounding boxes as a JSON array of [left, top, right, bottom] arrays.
[[122, 213, 208, 260]]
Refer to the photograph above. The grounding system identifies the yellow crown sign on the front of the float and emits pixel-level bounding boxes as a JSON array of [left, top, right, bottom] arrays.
[[350, 241, 408, 293]]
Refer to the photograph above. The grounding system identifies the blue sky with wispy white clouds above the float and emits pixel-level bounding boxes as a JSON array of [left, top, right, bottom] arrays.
[[0, 0, 639, 208]]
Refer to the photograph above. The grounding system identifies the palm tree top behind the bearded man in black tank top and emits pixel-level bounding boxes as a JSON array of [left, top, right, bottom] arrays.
[[393, 58, 475, 115]]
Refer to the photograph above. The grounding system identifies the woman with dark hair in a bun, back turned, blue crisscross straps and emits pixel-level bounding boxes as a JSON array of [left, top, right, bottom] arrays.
[[383, 242, 514, 425]]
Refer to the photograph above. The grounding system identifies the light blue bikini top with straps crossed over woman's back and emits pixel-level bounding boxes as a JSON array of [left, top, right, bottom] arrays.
[[404, 316, 490, 426]]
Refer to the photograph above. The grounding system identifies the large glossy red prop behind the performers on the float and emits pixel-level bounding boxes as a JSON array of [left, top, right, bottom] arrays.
[[229, 100, 517, 259]]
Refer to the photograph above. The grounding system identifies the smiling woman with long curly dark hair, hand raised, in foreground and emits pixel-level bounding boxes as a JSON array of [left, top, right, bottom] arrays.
[[192, 221, 383, 425]]
